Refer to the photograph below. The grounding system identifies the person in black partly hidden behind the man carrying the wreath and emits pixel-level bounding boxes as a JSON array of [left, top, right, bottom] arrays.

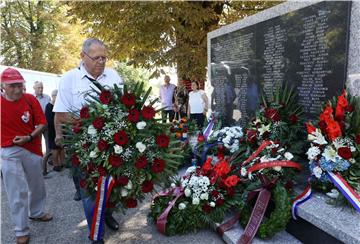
[[45, 90, 65, 171]]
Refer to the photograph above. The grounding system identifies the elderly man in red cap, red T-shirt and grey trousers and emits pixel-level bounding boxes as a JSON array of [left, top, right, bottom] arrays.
[[0, 68, 52, 244]]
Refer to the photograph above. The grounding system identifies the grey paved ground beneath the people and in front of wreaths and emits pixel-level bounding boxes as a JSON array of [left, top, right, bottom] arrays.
[[1, 166, 224, 244]]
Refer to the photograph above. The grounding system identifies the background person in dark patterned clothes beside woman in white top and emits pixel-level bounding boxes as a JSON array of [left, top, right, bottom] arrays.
[[174, 80, 189, 120]]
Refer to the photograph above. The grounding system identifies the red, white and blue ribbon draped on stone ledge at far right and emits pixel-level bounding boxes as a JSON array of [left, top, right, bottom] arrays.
[[326, 172, 360, 213]]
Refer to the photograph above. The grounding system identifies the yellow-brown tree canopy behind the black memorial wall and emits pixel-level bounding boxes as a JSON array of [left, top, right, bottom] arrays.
[[68, 1, 279, 80]]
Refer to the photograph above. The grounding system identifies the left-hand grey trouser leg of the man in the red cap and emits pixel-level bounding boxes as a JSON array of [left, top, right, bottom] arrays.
[[1, 147, 30, 236]]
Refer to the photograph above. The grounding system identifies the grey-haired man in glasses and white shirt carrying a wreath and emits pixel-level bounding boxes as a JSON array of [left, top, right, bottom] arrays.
[[53, 38, 123, 243]]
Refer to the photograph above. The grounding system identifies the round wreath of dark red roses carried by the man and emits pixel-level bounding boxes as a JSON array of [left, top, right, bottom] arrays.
[[66, 83, 183, 210]]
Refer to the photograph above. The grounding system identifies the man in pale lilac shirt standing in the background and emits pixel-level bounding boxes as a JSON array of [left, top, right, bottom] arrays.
[[160, 75, 176, 123]]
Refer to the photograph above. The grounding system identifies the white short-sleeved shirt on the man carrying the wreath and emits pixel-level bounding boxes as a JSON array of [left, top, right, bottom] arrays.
[[53, 63, 123, 112]]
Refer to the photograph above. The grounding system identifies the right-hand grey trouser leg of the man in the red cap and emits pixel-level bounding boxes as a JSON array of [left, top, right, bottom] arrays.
[[22, 149, 46, 218]]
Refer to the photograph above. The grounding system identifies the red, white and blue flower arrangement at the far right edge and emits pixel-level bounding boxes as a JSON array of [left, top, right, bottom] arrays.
[[306, 91, 360, 208]]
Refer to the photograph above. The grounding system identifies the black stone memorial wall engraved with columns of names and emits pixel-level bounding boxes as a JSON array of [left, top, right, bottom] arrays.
[[207, 1, 357, 124]]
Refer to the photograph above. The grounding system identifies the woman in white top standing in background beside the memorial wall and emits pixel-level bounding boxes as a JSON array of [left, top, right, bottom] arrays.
[[188, 81, 208, 129]]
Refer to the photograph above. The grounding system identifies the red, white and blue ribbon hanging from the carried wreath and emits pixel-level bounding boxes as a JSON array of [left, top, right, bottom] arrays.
[[90, 176, 115, 241]]
